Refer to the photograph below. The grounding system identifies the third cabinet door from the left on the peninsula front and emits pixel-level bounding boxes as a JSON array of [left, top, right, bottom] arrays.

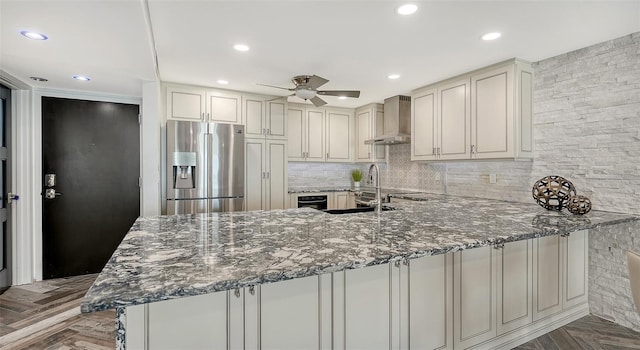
[[344, 264, 391, 350]]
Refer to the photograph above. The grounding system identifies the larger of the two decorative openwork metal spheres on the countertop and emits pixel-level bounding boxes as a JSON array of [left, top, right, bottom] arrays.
[[531, 175, 576, 210]]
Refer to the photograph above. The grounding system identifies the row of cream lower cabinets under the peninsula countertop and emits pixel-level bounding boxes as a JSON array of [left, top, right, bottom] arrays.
[[126, 231, 588, 350]]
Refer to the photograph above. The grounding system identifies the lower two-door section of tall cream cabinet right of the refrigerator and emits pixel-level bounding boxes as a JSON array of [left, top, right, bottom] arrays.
[[245, 138, 289, 210]]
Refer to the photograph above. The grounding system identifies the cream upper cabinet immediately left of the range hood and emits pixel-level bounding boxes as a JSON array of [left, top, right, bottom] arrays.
[[355, 103, 386, 163]]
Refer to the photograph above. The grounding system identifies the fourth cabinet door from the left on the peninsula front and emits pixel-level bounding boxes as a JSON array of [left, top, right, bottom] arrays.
[[410, 254, 453, 350]]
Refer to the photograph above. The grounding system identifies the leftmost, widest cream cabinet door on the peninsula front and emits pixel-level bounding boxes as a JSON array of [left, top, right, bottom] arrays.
[[147, 292, 227, 350]]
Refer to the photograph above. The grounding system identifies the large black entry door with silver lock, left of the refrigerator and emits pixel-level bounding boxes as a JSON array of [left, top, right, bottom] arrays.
[[42, 97, 140, 279]]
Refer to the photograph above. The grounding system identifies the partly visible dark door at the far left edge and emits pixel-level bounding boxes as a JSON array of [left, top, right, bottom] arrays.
[[0, 85, 13, 293]]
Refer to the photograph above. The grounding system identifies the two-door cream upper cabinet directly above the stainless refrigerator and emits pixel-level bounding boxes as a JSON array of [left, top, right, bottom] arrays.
[[165, 84, 242, 124]]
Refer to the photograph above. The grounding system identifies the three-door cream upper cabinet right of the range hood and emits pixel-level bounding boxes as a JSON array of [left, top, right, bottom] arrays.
[[411, 59, 533, 160]]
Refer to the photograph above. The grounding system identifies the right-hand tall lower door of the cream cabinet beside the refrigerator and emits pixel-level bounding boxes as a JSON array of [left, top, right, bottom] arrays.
[[265, 140, 287, 210]]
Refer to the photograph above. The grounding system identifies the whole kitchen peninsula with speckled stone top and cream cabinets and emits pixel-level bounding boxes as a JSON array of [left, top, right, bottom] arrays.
[[82, 194, 637, 349]]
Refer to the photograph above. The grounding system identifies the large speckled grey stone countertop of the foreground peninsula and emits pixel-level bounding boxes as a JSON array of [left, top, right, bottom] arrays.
[[81, 194, 638, 312]]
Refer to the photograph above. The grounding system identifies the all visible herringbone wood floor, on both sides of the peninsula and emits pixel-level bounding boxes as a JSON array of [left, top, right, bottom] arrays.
[[0, 275, 640, 350]]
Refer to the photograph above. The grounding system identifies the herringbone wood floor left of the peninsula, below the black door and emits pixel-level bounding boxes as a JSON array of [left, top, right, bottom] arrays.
[[0, 275, 115, 350]]
